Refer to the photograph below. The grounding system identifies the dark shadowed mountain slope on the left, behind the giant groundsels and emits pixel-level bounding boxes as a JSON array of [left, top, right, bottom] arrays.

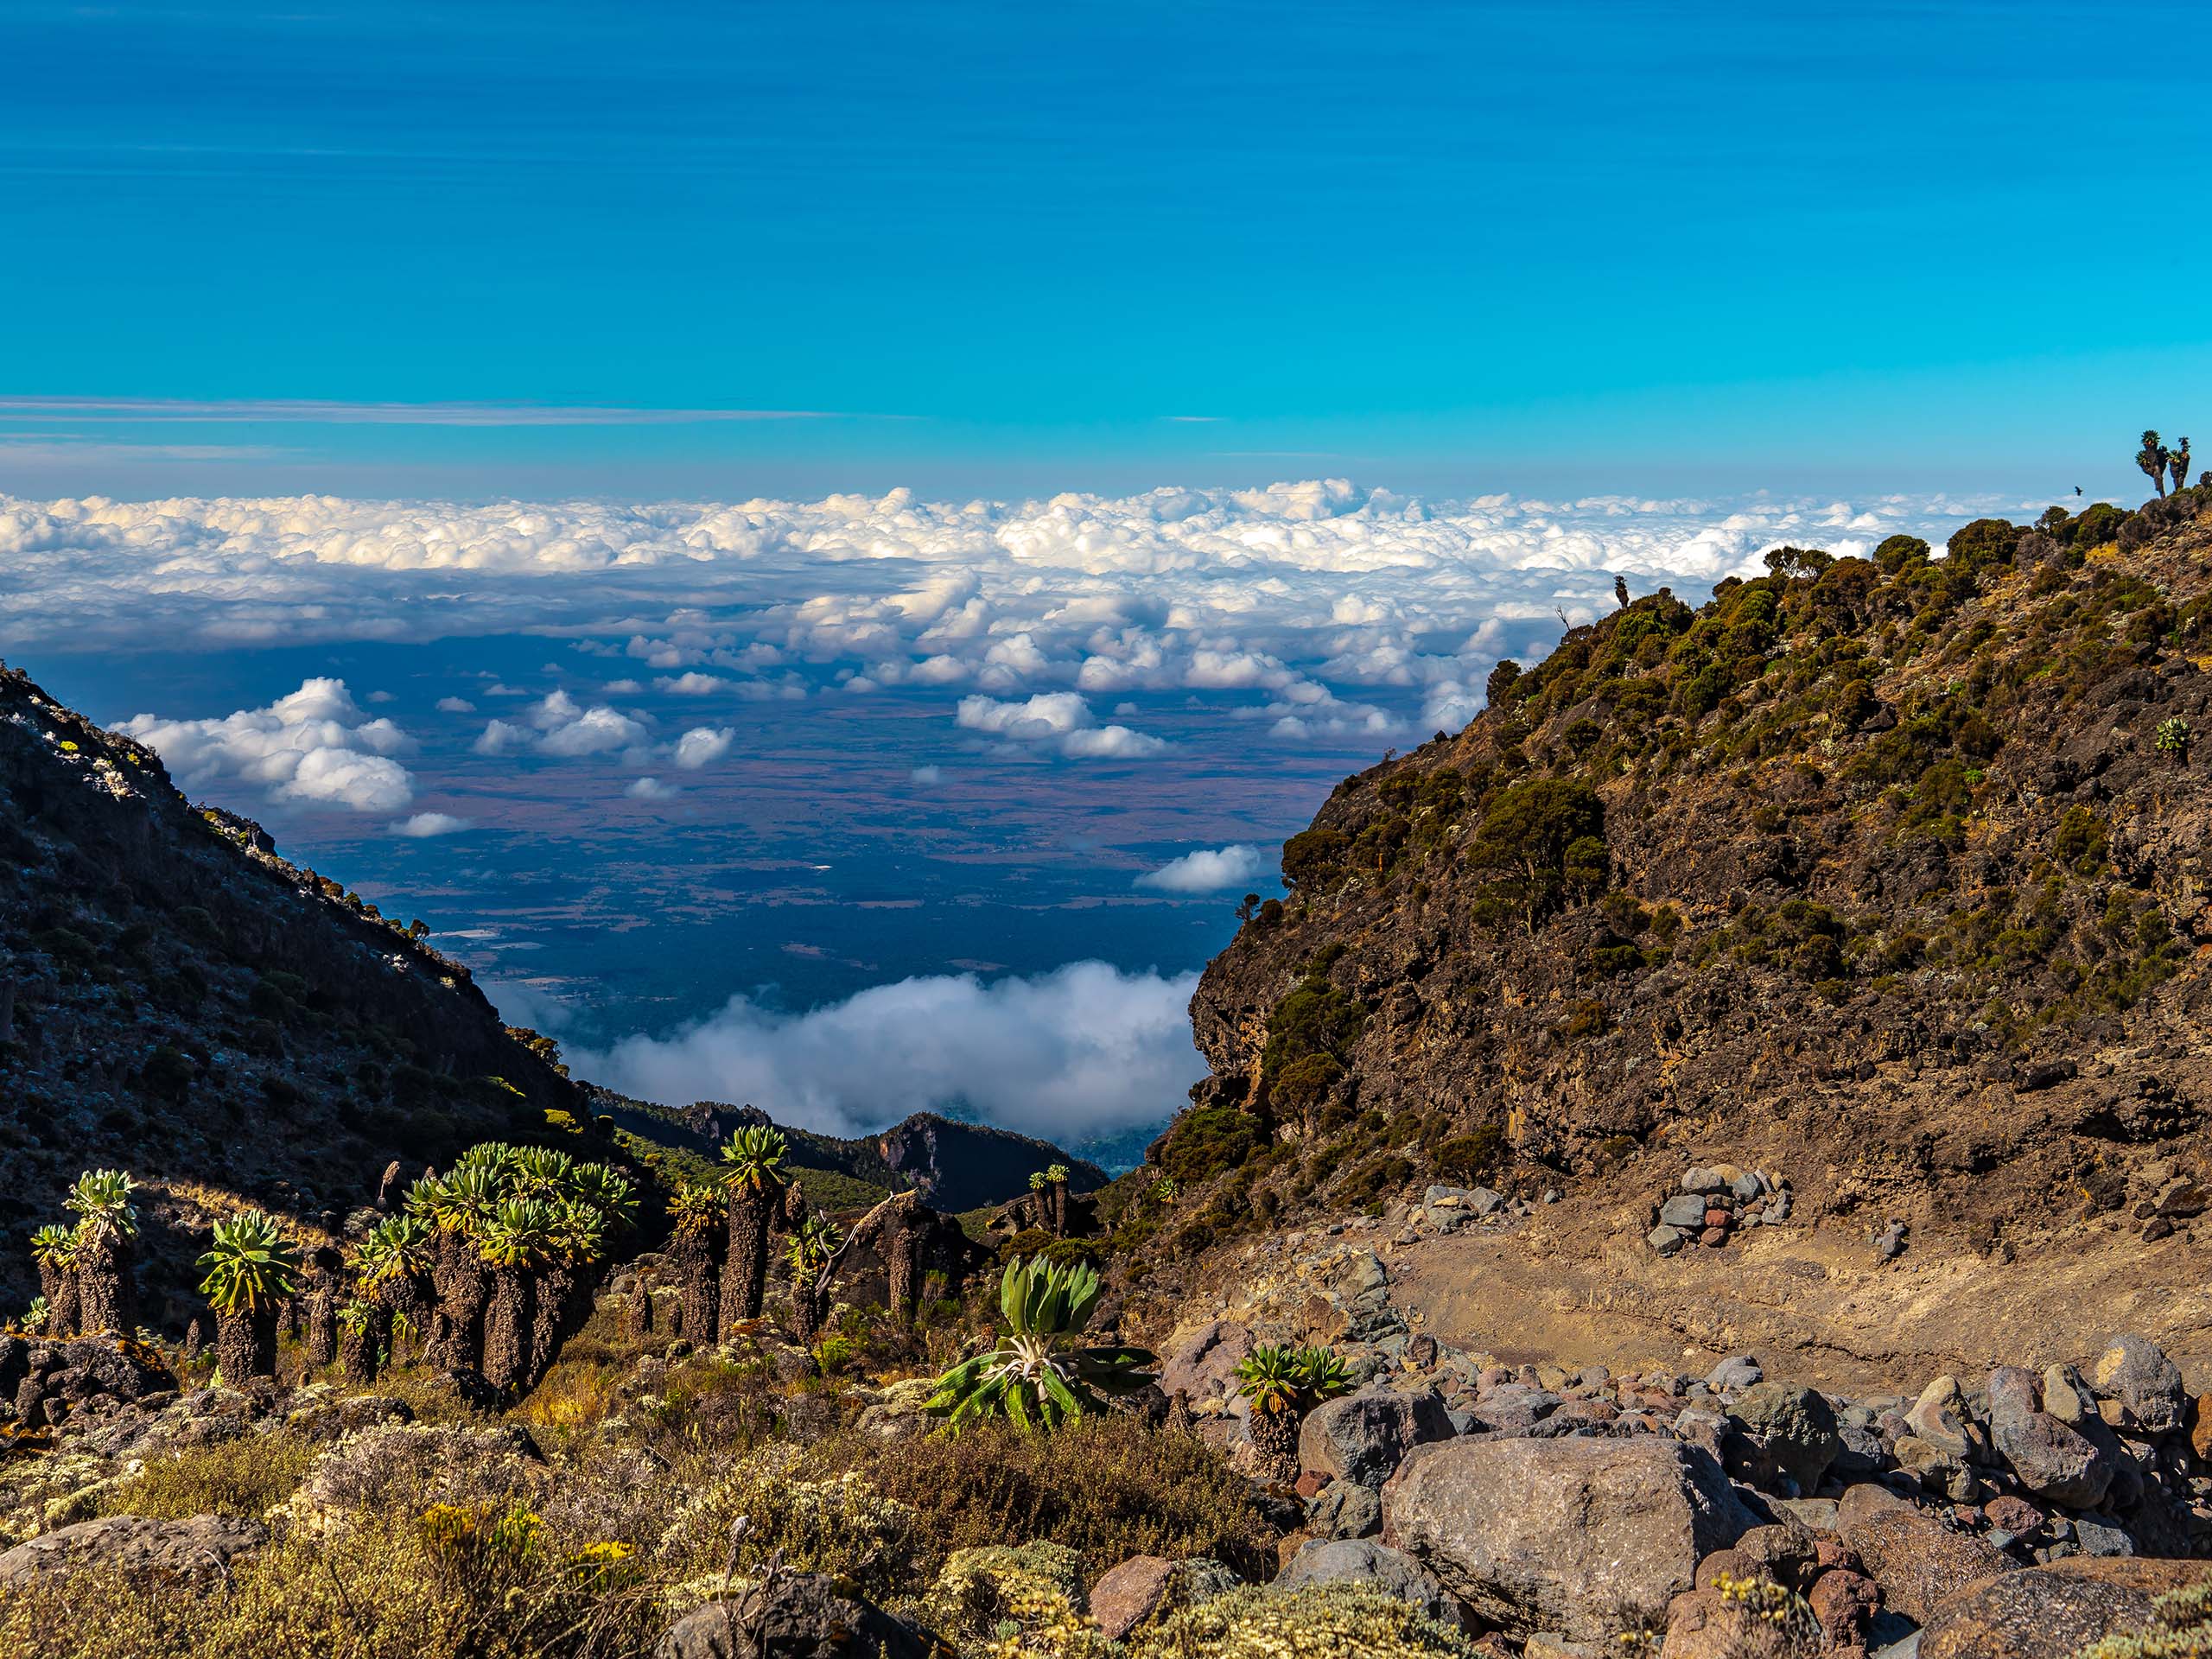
[[0, 668, 580, 1316]]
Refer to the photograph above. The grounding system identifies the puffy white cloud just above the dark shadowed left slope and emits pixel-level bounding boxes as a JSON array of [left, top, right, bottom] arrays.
[[118, 679, 414, 812]]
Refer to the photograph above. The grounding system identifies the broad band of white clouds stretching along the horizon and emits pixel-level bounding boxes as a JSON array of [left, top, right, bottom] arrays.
[[0, 480, 2019, 766]]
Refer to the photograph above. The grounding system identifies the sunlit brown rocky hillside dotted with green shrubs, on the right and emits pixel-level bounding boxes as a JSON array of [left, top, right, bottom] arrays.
[[1153, 491, 2212, 1371]]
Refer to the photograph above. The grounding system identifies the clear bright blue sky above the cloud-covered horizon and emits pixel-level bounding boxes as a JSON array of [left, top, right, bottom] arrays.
[[0, 0, 2212, 500]]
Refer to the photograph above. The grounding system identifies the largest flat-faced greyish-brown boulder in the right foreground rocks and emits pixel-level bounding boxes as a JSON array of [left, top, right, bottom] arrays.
[[1382, 1438, 1754, 1643]]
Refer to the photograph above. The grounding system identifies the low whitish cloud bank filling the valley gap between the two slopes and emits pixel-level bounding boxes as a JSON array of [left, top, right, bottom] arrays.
[[569, 963, 1205, 1137]]
